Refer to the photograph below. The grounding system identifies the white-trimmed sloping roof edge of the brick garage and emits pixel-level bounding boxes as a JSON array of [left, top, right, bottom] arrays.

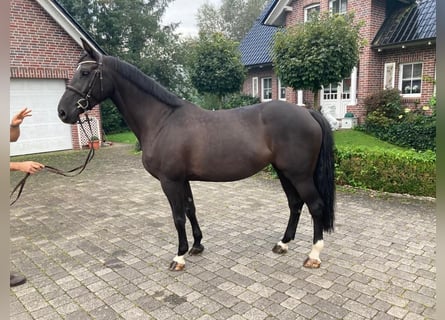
[[36, 0, 106, 54]]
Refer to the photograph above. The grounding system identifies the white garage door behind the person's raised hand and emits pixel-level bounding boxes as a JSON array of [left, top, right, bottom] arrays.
[[10, 79, 73, 155]]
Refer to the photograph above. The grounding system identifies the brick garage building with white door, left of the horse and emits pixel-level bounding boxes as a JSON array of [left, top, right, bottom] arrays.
[[10, 0, 103, 155]]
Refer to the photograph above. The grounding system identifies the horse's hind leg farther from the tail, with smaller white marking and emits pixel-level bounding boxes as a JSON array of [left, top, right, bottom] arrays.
[[272, 168, 304, 254]]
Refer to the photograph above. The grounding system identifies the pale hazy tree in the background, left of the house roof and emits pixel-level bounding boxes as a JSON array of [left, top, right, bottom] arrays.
[[197, 0, 268, 41]]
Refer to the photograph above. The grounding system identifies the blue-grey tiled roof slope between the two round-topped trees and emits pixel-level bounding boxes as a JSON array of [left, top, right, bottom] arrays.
[[239, 0, 279, 66]]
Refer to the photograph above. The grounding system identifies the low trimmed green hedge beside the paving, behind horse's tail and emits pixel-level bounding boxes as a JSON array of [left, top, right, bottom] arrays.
[[335, 146, 436, 197]]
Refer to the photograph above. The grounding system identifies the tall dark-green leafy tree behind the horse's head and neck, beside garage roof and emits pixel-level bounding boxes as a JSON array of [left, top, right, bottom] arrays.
[[59, 0, 188, 132]]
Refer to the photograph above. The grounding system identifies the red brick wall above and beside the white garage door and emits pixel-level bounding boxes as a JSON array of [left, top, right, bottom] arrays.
[[10, 0, 100, 148]]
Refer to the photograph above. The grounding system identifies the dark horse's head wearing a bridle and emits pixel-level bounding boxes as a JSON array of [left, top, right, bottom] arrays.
[[57, 39, 109, 124]]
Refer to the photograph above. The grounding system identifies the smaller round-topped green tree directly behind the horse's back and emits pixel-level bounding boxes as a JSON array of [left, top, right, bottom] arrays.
[[189, 33, 246, 109]]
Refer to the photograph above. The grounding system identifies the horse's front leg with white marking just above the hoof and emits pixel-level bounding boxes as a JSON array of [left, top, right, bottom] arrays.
[[161, 180, 189, 271]]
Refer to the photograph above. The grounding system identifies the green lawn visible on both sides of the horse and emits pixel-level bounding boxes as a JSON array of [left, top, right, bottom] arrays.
[[107, 130, 404, 150]]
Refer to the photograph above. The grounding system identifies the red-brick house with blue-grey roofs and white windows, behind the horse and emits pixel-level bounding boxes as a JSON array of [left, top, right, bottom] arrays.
[[240, 0, 436, 124]]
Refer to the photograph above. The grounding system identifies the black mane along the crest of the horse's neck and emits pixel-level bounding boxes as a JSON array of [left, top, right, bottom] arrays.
[[104, 56, 184, 107]]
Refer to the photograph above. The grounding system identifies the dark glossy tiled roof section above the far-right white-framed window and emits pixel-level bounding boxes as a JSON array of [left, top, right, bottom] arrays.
[[372, 0, 436, 48]]
